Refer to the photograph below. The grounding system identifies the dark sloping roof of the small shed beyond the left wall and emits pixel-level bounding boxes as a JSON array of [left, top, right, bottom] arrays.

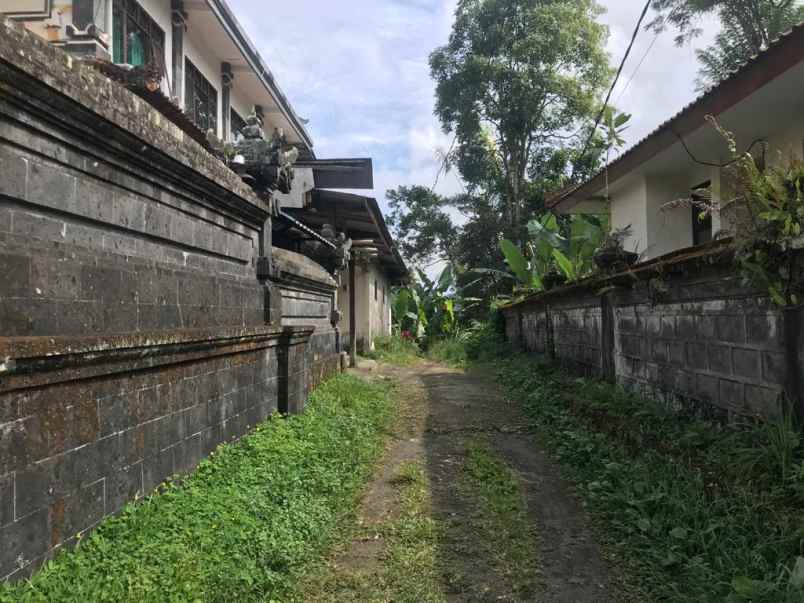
[[285, 189, 408, 281]]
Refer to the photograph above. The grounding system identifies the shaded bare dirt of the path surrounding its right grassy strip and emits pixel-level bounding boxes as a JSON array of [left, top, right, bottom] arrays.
[[418, 363, 621, 603]]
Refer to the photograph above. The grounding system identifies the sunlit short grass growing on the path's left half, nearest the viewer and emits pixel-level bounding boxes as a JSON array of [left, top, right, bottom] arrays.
[[304, 461, 446, 603]]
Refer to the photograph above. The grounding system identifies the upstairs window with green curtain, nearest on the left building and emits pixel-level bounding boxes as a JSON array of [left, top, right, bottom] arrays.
[[112, 0, 165, 73]]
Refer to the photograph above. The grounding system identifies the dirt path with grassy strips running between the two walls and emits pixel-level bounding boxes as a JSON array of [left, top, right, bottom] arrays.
[[310, 362, 627, 603]]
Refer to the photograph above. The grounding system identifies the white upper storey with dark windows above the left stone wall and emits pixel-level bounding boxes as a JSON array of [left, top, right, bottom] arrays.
[[6, 0, 313, 151]]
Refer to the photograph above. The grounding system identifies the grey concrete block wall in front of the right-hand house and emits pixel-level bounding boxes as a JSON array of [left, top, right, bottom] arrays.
[[504, 243, 804, 417]]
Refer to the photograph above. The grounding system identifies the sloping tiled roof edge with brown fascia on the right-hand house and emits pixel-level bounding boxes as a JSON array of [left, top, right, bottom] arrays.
[[545, 23, 804, 211]]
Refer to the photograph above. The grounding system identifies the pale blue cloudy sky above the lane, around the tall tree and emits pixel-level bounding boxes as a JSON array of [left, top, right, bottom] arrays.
[[230, 0, 713, 216]]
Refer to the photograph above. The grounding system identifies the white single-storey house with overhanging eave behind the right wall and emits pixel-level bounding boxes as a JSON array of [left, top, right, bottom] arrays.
[[548, 24, 804, 260]]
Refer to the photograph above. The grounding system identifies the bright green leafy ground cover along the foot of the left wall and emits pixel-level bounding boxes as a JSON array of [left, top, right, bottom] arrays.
[[0, 375, 392, 603]]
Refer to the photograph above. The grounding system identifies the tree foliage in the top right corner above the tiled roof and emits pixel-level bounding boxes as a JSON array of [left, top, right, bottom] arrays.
[[648, 0, 804, 89]]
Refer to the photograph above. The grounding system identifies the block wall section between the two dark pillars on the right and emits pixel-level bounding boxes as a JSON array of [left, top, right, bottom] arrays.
[[614, 298, 787, 415]]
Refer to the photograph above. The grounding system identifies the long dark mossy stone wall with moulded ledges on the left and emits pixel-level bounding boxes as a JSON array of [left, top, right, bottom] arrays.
[[0, 23, 337, 579]]
